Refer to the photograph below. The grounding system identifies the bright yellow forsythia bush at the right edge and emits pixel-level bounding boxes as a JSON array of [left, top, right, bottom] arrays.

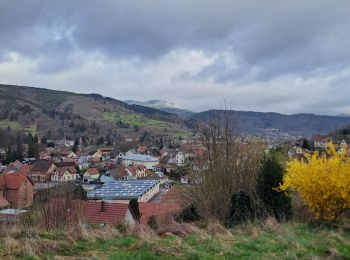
[[278, 143, 350, 221]]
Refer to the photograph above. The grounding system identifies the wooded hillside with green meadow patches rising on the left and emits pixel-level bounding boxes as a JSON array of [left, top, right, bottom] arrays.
[[0, 84, 187, 141]]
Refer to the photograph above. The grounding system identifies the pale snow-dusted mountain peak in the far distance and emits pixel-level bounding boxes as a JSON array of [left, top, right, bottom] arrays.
[[124, 99, 195, 118]]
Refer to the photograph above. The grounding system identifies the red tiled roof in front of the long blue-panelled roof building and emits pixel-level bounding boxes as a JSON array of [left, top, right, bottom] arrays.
[[80, 200, 129, 225]]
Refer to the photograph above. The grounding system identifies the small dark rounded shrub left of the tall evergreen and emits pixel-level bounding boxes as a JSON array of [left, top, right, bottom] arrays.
[[226, 190, 253, 227]]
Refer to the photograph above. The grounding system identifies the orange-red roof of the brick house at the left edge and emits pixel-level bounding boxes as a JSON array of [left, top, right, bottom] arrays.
[[0, 165, 34, 190]]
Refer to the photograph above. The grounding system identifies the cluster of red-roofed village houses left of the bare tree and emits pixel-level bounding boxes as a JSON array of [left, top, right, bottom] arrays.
[[0, 140, 202, 224]]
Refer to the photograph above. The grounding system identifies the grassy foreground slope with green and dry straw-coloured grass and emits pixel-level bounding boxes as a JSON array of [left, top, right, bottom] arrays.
[[0, 222, 350, 259]]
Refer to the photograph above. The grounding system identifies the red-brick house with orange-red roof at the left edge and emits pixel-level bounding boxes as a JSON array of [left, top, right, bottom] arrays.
[[0, 165, 34, 209]]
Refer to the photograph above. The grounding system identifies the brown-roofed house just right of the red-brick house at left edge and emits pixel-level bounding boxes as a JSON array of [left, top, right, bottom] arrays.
[[29, 160, 57, 182]]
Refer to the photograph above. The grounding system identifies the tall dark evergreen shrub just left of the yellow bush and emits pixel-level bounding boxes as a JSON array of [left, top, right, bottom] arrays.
[[256, 158, 292, 221]]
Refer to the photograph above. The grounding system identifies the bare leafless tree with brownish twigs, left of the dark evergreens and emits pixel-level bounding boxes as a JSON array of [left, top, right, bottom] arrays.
[[185, 110, 263, 220]]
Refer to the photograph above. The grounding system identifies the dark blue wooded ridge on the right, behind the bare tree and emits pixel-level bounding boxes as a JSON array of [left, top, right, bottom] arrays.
[[189, 110, 350, 137]]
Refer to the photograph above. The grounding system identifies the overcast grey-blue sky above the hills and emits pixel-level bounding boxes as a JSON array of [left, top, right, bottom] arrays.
[[0, 0, 350, 115]]
